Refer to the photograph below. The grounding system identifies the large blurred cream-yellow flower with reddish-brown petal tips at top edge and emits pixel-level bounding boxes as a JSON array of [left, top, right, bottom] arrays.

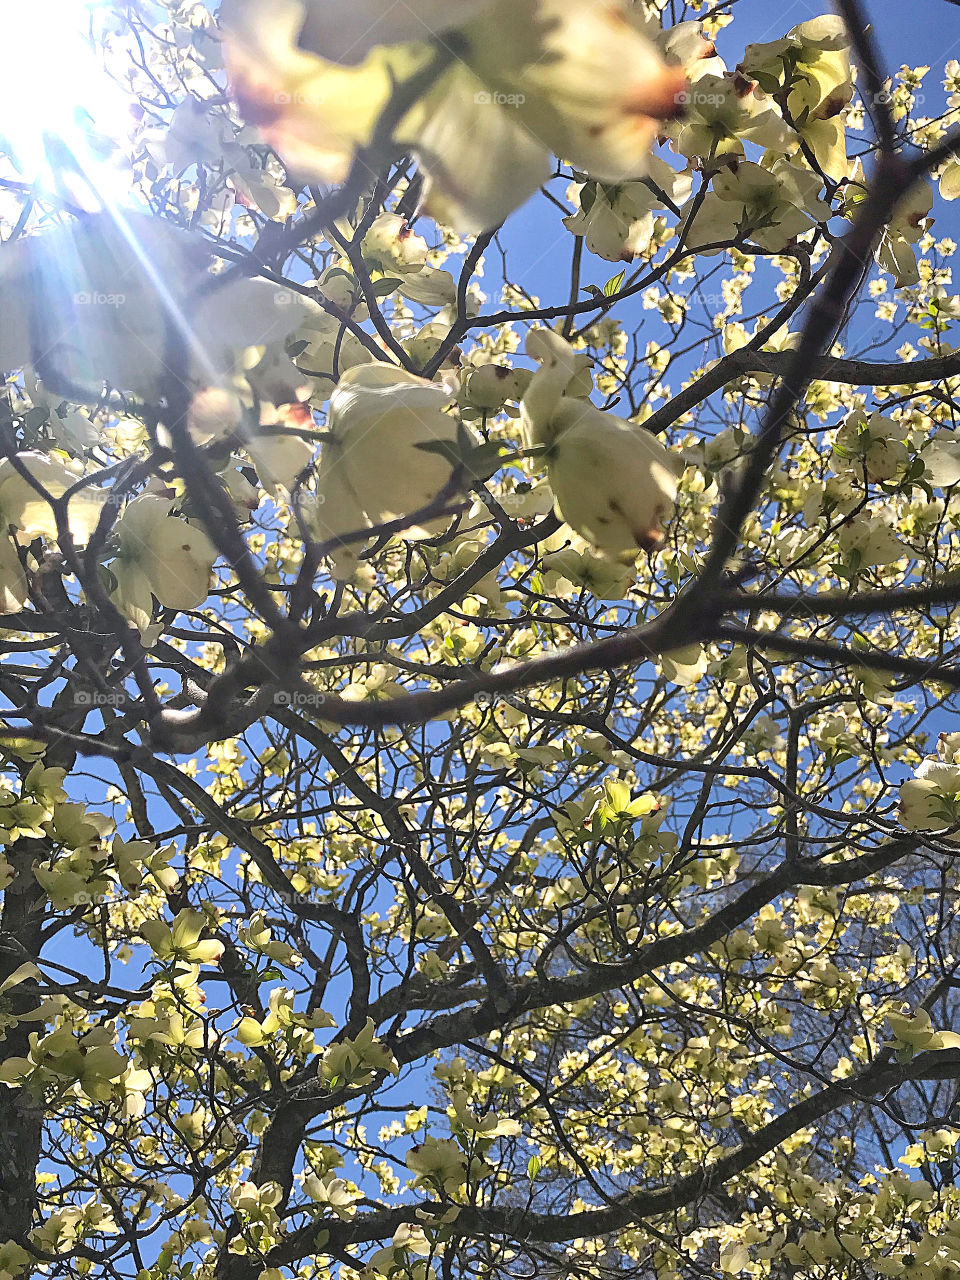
[[221, 0, 686, 230]]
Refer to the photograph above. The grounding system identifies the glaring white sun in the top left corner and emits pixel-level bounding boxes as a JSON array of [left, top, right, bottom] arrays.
[[0, 0, 129, 204]]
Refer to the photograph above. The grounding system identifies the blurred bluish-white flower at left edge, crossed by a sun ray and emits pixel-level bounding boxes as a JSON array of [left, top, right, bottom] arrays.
[[0, 212, 312, 403]]
